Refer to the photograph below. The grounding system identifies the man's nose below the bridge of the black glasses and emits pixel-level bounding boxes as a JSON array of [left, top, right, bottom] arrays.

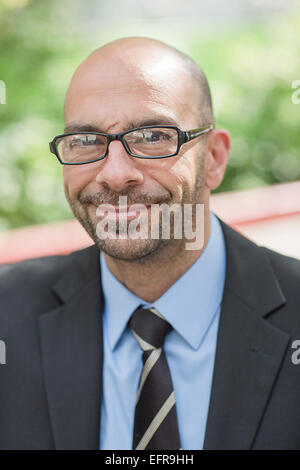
[[96, 141, 143, 192]]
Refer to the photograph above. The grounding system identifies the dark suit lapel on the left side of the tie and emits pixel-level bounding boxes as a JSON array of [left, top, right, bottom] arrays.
[[39, 246, 103, 449]]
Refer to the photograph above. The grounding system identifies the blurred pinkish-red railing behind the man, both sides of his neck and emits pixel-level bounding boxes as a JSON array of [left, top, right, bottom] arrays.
[[0, 182, 300, 263]]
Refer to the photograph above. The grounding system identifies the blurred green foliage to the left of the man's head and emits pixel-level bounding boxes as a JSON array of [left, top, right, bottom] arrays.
[[0, 0, 87, 229]]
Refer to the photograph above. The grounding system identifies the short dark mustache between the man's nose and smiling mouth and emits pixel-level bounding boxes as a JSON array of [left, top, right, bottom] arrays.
[[78, 191, 172, 206]]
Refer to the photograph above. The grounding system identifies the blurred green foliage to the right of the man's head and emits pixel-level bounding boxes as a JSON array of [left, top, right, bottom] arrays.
[[191, 14, 300, 192]]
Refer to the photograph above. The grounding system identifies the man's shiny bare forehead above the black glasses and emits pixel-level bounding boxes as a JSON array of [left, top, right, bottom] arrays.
[[65, 49, 196, 128]]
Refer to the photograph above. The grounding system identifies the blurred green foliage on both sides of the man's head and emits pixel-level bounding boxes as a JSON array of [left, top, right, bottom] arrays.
[[0, 0, 300, 230]]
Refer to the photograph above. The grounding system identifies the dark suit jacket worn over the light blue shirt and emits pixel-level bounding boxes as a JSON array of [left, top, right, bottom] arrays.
[[0, 218, 300, 449]]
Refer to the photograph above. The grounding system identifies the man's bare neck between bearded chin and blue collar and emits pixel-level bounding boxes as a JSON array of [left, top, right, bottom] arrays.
[[104, 207, 210, 302]]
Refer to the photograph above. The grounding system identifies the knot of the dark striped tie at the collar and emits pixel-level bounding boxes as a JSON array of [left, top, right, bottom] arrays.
[[129, 307, 172, 351]]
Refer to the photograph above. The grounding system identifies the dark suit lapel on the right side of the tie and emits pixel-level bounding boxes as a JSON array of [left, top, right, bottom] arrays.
[[204, 222, 289, 449]]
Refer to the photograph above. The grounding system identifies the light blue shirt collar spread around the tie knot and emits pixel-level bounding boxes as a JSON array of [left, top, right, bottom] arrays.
[[100, 212, 226, 350]]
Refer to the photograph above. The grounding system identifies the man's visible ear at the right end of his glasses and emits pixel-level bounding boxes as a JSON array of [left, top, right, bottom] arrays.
[[205, 129, 230, 190]]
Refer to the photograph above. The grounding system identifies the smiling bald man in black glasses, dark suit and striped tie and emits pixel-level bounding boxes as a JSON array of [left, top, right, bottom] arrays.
[[0, 38, 300, 449]]
